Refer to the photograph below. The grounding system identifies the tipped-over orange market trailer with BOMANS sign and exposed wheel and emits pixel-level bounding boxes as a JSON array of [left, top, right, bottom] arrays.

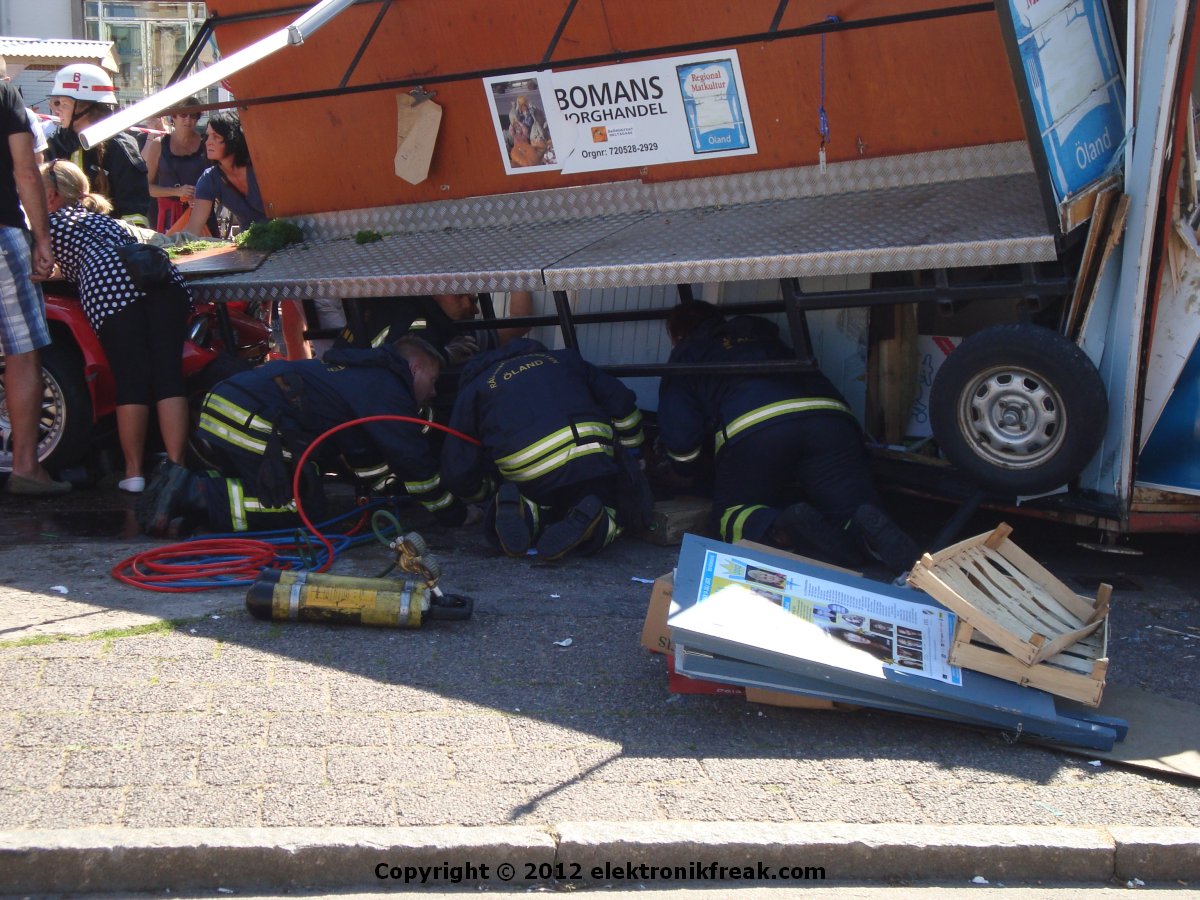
[[114, 0, 1200, 535]]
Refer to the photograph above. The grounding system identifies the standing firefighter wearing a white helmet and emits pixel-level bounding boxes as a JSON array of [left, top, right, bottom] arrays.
[[46, 62, 154, 228]]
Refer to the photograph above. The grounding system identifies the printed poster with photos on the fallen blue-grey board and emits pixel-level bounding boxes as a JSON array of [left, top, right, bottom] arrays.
[[700, 551, 962, 684]]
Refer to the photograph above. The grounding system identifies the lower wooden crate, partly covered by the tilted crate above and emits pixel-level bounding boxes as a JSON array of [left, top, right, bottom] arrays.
[[949, 618, 1109, 707]]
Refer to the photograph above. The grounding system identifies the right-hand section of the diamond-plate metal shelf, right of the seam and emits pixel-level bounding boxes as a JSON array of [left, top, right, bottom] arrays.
[[546, 175, 1055, 290]]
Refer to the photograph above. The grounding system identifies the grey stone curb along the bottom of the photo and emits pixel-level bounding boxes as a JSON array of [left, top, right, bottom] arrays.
[[0, 822, 1200, 894]]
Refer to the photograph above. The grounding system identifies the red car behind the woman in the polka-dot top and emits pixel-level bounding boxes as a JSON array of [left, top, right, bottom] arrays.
[[0, 282, 270, 473]]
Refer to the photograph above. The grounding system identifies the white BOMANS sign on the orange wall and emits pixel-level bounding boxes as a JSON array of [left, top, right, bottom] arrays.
[[484, 50, 757, 174]]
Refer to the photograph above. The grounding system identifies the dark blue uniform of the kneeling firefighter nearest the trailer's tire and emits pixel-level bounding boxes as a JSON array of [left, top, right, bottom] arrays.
[[659, 316, 880, 542]]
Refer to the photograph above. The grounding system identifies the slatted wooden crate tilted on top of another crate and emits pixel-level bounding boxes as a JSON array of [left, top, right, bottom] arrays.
[[908, 523, 1112, 668]]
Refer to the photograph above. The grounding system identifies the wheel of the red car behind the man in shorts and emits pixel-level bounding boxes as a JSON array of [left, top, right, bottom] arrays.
[[0, 343, 94, 473]]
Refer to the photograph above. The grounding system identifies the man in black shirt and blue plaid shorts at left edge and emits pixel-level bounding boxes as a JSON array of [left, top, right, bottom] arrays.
[[0, 59, 71, 497]]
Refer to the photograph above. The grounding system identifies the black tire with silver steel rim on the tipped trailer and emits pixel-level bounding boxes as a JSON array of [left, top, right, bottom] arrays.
[[930, 325, 1109, 496]]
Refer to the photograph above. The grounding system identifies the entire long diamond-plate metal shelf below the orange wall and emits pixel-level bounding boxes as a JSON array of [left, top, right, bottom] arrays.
[[182, 143, 1055, 300]]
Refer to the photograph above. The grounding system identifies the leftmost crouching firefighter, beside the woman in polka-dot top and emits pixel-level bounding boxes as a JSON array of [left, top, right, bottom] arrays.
[[138, 336, 463, 535]]
